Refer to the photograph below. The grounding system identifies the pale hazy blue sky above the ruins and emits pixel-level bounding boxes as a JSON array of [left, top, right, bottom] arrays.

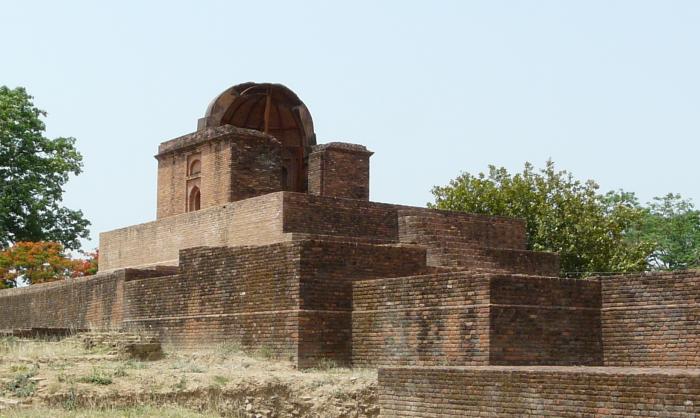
[[0, 0, 700, 251]]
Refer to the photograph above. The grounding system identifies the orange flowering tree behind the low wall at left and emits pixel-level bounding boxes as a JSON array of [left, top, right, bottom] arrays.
[[0, 241, 98, 287]]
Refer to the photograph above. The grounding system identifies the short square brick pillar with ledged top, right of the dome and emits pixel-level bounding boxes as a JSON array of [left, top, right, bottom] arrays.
[[309, 142, 373, 200]]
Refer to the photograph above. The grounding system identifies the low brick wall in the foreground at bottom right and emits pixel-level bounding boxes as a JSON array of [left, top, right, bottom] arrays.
[[379, 366, 700, 417]]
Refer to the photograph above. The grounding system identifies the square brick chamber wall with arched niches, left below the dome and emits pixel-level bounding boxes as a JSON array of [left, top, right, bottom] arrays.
[[156, 125, 284, 219]]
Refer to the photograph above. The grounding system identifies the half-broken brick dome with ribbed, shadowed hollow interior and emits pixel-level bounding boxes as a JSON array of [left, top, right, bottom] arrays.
[[197, 82, 316, 192]]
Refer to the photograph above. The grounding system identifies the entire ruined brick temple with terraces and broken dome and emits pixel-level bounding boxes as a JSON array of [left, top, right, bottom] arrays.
[[0, 83, 700, 417]]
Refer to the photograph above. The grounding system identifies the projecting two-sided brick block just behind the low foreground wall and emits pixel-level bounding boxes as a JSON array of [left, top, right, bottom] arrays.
[[352, 272, 602, 366]]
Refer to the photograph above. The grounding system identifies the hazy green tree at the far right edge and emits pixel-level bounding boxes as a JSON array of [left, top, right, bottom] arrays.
[[639, 193, 700, 270]]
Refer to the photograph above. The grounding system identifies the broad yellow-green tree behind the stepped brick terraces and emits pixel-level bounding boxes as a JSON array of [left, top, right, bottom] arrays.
[[428, 161, 653, 275]]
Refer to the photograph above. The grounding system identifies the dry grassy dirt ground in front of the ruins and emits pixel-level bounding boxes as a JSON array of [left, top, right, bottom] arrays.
[[0, 337, 379, 417]]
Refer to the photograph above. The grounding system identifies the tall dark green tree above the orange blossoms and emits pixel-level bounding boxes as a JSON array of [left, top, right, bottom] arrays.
[[0, 86, 90, 249]]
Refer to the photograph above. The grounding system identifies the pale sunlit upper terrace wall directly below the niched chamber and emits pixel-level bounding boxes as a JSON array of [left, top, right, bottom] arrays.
[[100, 193, 287, 271]]
